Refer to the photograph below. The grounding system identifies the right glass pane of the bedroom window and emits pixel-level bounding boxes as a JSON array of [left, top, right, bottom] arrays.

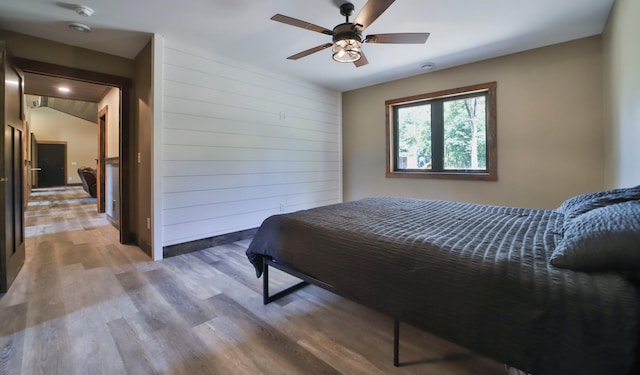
[[443, 95, 487, 170]]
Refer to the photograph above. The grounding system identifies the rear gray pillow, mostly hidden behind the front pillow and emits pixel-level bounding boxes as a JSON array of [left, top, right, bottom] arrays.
[[556, 185, 640, 221]]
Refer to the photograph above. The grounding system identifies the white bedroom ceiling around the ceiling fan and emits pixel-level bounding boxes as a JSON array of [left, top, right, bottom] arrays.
[[0, 0, 614, 91]]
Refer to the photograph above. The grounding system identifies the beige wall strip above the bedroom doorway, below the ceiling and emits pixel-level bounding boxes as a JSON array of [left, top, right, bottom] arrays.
[[0, 29, 133, 78]]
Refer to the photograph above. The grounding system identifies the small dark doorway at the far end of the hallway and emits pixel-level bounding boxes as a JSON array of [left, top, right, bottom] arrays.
[[36, 142, 67, 188]]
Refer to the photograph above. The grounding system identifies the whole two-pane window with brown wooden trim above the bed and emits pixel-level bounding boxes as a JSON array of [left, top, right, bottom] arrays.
[[385, 82, 497, 180]]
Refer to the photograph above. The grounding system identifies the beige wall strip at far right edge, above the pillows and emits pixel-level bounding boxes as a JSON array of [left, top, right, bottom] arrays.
[[603, 0, 640, 188]]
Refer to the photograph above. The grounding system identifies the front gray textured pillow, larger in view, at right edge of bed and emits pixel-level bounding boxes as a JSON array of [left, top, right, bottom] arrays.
[[549, 201, 640, 271]]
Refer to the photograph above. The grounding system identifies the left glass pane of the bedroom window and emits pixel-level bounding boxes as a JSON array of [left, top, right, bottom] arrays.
[[396, 104, 431, 169]]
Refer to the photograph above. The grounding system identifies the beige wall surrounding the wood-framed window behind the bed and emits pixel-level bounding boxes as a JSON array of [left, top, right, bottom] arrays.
[[343, 36, 604, 208]]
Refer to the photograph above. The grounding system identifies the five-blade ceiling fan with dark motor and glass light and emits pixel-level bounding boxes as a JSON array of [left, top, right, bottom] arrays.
[[271, 0, 429, 67]]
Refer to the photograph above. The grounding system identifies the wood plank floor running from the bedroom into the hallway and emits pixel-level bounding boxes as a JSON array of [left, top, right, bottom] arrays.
[[0, 189, 505, 375]]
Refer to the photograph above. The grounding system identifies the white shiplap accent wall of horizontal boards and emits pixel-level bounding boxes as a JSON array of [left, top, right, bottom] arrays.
[[162, 44, 342, 246]]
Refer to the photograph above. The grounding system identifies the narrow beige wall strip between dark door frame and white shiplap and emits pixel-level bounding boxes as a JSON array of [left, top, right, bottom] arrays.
[[132, 43, 153, 255]]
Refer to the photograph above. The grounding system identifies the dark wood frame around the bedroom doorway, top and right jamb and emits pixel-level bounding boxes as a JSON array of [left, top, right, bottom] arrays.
[[15, 58, 135, 243]]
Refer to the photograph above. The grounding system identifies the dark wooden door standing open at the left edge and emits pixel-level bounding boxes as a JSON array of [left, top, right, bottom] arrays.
[[0, 42, 25, 293]]
